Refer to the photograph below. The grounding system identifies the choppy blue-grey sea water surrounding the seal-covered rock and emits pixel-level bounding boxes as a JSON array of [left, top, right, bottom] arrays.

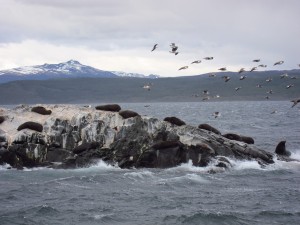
[[0, 101, 300, 225]]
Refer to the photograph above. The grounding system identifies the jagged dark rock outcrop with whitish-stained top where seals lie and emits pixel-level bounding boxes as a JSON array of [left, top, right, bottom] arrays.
[[0, 105, 273, 168]]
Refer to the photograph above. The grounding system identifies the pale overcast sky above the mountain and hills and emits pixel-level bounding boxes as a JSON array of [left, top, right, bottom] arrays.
[[0, 0, 300, 76]]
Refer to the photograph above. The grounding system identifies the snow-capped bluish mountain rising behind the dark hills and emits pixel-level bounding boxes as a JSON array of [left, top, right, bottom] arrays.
[[0, 60, 158, 83]]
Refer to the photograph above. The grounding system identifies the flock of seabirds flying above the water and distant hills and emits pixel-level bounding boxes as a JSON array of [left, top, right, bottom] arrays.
[[148, 43, 300, 112]]
